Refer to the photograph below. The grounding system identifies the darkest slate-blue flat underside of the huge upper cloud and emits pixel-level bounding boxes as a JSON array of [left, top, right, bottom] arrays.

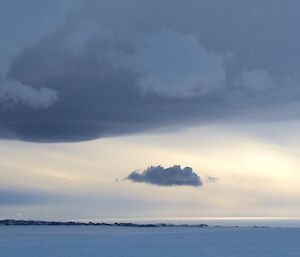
[[0, 40, 260, 142]]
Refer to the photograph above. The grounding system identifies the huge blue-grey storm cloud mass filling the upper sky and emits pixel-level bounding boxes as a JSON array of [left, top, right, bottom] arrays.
[[0, 0, 300, 142]]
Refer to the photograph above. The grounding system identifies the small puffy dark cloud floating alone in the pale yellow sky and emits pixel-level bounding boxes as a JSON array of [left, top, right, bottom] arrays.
[[125, 165, 202, 187]]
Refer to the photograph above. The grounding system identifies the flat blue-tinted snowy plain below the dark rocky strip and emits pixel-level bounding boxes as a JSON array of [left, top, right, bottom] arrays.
[[0, 226, 300, 257]]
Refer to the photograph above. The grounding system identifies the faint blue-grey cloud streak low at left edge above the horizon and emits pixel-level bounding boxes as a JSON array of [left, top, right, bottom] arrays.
[[0, 189, 53, 206]]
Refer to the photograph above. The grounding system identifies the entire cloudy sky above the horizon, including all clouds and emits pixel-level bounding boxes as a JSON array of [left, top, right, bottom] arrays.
[[0, 0, 300, 220]]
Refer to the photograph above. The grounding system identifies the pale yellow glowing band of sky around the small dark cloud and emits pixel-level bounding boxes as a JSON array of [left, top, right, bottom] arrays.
[[0, 123, 300, 218]]
